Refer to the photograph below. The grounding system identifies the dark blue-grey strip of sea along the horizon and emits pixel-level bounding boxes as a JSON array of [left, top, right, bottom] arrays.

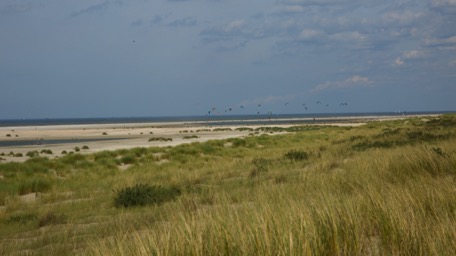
[[0, 111, 454, 127]]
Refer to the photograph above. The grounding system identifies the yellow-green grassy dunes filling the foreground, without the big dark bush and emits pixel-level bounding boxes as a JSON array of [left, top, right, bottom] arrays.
[[0, 115, 456, 255]]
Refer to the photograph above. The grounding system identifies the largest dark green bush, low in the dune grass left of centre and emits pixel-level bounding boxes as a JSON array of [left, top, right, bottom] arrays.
[[114, 184, 181, 208]]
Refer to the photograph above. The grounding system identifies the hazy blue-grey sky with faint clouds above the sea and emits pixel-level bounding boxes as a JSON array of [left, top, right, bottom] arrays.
[[0, 0, 456, 119]]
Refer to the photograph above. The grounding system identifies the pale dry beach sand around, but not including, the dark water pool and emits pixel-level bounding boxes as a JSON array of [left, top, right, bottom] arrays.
[[0, 115, 438, 162]]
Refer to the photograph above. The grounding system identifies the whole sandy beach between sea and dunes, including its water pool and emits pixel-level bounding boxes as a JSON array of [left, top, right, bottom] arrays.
[[0, 113, 448, 162]]
